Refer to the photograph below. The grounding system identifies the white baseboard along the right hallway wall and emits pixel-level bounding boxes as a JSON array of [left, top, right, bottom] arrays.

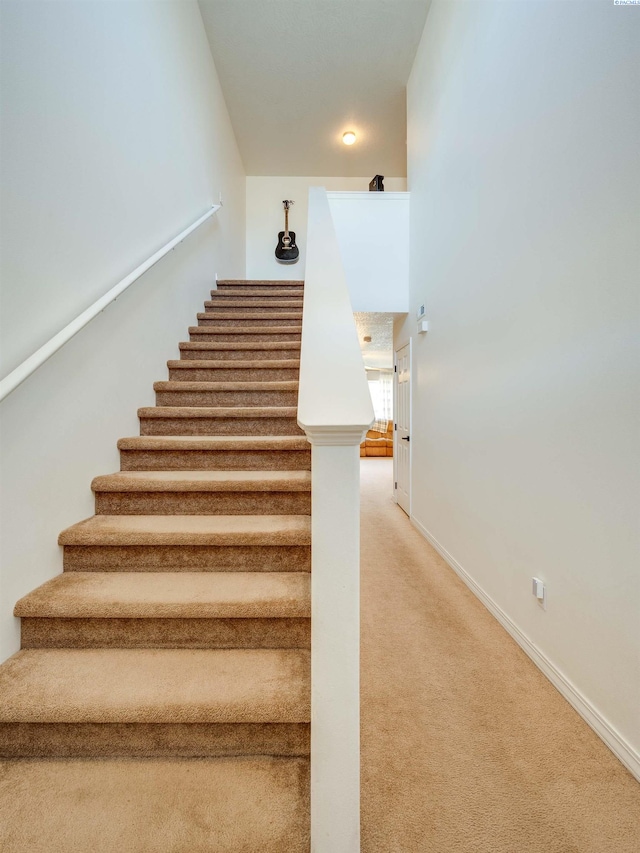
[[411, 516, 640, 781]]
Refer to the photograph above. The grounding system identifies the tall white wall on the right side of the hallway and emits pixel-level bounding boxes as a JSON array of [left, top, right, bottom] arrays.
[[396, 0, 640, 772]]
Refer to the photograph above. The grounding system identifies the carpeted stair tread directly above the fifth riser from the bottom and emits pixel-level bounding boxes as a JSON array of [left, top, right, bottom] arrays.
[[118, 435, 310, 450]]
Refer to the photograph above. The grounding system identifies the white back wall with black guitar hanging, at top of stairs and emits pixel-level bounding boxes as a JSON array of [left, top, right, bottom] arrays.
[[247, 175, 407, 281]]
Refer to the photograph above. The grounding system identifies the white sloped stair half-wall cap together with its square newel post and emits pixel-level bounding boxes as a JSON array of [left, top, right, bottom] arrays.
[[298, 187, 373, 853]]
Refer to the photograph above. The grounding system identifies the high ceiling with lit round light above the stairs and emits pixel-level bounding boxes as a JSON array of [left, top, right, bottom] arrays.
[[199, 0, 430, 177]]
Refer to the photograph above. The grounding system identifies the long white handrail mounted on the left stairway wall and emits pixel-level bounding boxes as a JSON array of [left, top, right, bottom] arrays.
[[0, 204, 222, 402]]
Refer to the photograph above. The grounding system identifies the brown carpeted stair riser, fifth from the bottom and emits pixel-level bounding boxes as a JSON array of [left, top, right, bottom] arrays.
[[120, 450, 311, 471]]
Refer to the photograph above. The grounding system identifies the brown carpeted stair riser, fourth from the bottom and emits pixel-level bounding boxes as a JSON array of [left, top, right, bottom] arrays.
[[96, 492, 311, 515]]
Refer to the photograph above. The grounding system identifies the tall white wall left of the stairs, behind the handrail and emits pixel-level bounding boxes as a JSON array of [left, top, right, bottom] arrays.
[[0, 2, 245, 657]]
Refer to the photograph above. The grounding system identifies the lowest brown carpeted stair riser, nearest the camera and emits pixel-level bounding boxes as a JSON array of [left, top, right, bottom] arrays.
[[0, 723, 310, 758]]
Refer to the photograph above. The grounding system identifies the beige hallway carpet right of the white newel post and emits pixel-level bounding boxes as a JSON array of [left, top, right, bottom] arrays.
[[361, 459, 640, 853]]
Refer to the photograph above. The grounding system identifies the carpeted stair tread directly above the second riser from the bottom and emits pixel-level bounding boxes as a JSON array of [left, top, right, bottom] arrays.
[[14, 572, 311, 619]]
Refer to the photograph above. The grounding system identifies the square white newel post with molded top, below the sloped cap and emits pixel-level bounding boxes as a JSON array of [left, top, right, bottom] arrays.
[[307, 426, 363, 853]]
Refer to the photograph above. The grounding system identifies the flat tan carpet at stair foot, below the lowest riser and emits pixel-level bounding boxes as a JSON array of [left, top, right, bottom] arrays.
[[0, 757, 310, 853]]
